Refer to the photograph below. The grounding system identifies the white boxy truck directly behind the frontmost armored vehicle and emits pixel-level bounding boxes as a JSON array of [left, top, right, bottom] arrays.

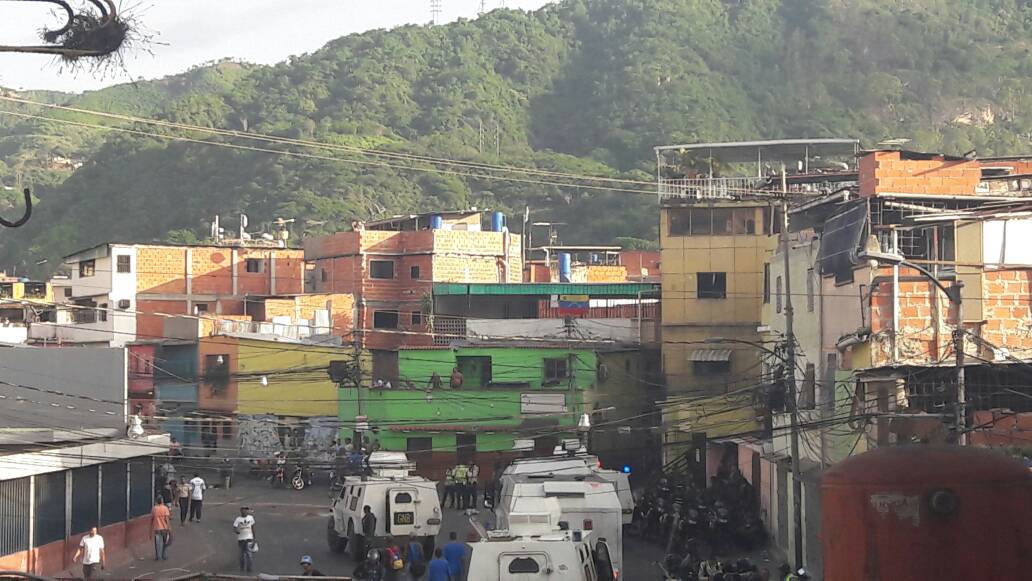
[[494, 474, 623, 574]]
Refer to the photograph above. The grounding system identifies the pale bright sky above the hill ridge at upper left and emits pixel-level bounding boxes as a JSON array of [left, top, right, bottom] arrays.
[[0, 0, 548, 92]]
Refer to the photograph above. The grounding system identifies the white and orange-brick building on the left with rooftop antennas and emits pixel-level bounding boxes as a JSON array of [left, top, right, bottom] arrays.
[[29, 240, 304, 346]]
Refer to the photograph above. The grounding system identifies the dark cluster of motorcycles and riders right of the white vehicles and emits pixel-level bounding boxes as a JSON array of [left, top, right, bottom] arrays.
[[631, 472, 766, 578]]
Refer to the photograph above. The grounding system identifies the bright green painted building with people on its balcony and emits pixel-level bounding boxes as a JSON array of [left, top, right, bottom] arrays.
[[340, 342, 599, 478]]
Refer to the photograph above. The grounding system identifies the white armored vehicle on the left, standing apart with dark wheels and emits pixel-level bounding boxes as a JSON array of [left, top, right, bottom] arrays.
[[326, 452, 442, 560]]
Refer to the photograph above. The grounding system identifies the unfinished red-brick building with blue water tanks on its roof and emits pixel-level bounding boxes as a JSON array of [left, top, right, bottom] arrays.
[[304, 211, 522, 359]]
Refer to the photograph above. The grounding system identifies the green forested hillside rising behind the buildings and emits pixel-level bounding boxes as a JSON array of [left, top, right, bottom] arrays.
[[0, 0, 1032, 274]]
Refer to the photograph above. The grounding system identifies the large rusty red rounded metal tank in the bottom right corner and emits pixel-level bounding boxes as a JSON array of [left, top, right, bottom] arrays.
[[820, 445, 1032, 581]]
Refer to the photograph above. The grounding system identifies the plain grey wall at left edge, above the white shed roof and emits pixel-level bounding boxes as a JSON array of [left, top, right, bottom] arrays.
[[0, 347, 128, 431]]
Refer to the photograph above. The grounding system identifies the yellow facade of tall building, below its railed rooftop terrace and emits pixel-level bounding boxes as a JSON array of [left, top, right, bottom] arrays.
[[659, 204, 777, 457]]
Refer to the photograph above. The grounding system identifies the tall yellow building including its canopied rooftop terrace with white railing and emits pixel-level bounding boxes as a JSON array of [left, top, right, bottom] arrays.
[[656, 139, 858, 466]]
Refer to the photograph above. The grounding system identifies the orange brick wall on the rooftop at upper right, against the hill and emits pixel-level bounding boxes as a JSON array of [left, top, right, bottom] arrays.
[[860, 152, 981, 197]]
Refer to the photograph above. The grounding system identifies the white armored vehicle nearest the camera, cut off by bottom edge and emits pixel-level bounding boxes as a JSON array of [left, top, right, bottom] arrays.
[[469, 530, 615, 581]]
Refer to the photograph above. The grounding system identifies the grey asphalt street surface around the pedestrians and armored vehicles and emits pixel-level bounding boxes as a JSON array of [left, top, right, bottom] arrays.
[[102, 480, 663, 581]]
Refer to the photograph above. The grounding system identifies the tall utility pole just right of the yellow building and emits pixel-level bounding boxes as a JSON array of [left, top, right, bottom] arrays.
[[781, 170, 804, 569]]
